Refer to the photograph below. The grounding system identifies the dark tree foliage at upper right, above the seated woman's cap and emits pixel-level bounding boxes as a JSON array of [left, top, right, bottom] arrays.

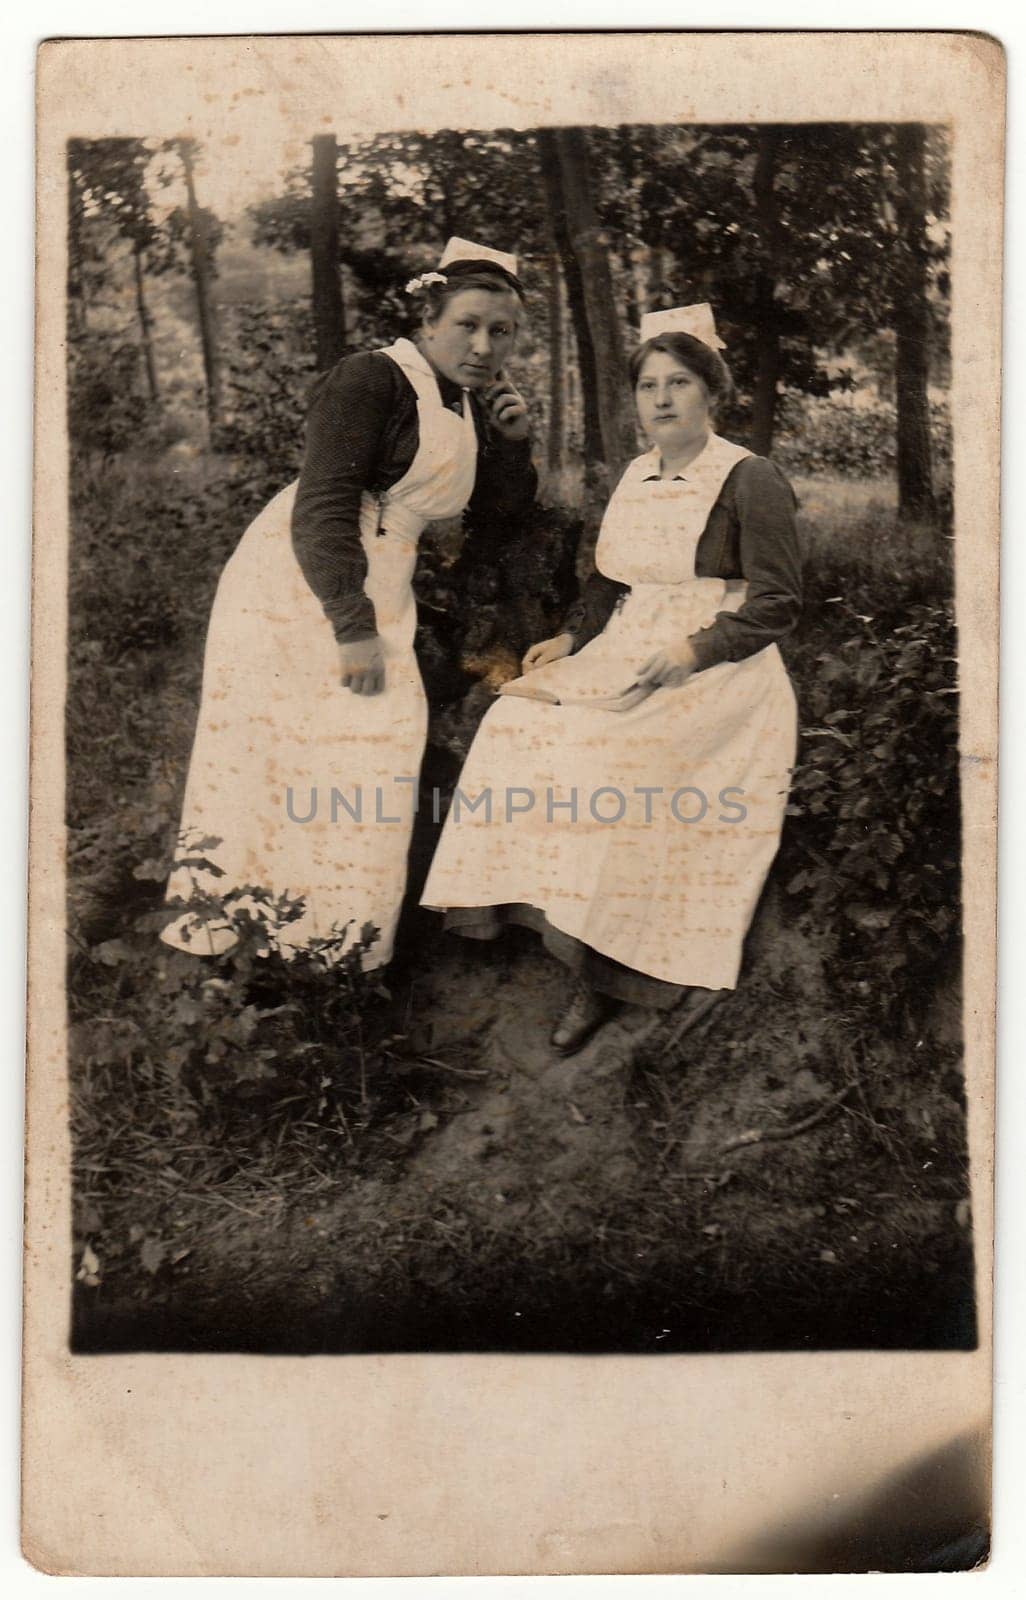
[[592, 123, 949, 395]]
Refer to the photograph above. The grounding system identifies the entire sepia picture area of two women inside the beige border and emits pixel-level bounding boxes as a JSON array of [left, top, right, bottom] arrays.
[[66, 122, 976, 1355]]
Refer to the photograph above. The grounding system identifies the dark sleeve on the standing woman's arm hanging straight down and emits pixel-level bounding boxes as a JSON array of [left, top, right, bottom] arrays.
[[291, 352, 406, 643]]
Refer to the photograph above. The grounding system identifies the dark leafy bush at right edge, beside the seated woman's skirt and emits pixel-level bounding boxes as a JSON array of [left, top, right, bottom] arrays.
[[776, 534, 960, 1018]]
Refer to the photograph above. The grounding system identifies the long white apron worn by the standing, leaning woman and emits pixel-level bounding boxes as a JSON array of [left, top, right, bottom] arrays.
[[162, 339, 477, 968]]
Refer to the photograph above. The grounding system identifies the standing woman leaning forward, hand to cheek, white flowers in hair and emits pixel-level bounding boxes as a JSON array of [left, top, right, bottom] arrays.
[[162, 238, 536, 968]]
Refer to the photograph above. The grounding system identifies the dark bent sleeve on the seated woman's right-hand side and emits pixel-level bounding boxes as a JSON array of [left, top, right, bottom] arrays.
[[690, 456, 802, 672]]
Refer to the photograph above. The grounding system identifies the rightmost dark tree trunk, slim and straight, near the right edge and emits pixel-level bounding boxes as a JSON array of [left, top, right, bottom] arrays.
[[895, 123, 936, 522]]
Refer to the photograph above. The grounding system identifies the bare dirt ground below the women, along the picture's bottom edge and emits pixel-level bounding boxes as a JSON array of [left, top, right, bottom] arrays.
[[75, 891, 975, 1352]]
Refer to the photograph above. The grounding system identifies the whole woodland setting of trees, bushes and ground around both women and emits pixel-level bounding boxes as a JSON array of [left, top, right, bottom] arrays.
[[67, 123, 973, 1349]]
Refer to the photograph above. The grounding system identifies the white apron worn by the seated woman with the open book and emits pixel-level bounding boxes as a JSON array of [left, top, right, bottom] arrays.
[[424, 435, 797, 989]]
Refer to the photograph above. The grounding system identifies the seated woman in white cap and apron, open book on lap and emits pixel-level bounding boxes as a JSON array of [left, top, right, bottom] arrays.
[[423, 306, 800, 1054]]
